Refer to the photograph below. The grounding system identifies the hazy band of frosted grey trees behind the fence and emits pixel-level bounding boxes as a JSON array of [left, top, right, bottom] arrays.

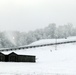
[[0, 23, 76, 48]]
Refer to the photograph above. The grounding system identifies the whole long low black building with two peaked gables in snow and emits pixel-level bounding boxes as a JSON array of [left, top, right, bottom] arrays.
[[0, 52, 36, 62]]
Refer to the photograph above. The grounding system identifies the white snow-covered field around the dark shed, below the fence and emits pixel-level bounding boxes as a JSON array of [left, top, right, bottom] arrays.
[[0, 37, 76, 75]]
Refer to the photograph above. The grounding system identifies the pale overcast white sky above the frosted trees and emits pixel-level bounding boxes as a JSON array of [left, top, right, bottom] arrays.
[[0, 0, 76, 32]]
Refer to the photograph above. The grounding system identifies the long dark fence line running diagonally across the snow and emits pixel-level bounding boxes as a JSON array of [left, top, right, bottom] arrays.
[[0, 41, 76, 52]]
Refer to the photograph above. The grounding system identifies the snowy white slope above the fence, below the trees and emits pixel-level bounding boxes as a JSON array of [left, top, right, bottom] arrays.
[[30, 36, 76, 45]]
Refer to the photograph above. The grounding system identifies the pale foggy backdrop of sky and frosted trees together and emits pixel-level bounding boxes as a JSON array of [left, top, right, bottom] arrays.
[[0, 0, 76, 48]]
